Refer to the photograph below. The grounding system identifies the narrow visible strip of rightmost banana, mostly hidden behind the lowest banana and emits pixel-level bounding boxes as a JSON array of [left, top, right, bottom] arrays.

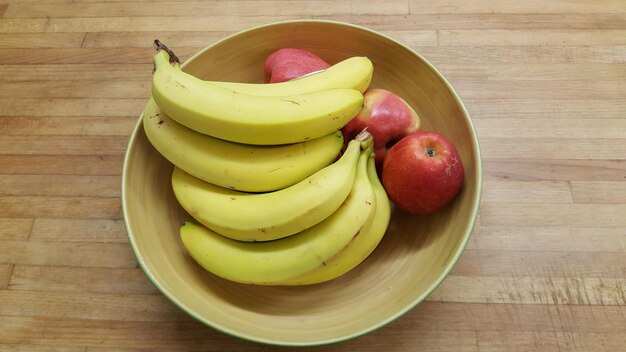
[[282, 155, 391, 285]]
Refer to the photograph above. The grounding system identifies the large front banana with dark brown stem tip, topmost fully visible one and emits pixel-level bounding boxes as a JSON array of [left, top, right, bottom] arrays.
[[152, 50, 363, 145]]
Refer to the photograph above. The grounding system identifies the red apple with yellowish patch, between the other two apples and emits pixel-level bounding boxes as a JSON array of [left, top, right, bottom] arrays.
[[342, 89, 420, 169]]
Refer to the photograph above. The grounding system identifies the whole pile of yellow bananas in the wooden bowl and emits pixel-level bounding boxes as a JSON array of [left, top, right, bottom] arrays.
[[142, 41, 390, 285]]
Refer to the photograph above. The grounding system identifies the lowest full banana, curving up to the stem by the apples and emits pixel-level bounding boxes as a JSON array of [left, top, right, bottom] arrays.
[[180, 148, 376, 285]]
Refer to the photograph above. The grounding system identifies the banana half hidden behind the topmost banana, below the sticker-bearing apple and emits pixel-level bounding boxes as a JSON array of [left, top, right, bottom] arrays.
[[209, 56, 374, 97]]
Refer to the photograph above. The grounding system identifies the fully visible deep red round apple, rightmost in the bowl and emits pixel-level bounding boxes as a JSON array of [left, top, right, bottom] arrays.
[[382, 131, 465, 214]]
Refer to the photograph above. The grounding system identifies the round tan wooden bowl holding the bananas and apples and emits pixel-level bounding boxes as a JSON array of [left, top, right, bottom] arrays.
[[122, 21, 482, 346]]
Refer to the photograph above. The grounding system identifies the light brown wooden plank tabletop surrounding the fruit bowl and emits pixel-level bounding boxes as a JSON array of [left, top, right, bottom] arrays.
[[0, 0, 626, 352]]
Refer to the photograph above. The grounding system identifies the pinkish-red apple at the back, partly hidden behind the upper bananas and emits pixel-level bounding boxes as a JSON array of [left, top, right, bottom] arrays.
[[264, 48, 330, 83]]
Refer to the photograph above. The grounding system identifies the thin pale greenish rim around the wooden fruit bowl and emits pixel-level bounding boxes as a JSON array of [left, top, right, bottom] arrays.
[[121, 19, 483, 347]]
